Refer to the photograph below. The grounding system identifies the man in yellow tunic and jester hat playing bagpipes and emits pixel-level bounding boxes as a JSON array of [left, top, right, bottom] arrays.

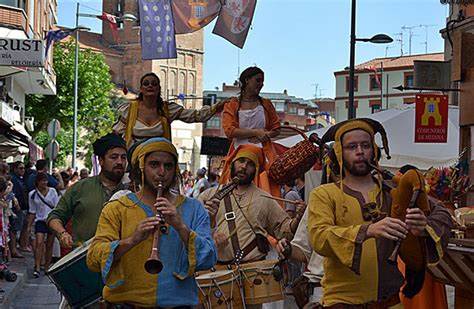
[[308, 119, 452, 309]]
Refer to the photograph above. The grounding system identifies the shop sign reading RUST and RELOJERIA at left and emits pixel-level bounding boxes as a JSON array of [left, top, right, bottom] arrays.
[[0, 38, 44, 67]]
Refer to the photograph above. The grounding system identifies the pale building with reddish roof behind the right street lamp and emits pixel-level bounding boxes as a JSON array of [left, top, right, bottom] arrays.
[[334, 53, 444, 122]]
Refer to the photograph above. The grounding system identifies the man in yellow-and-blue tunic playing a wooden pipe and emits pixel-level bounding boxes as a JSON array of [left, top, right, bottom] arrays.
[[87, 138, 217, 308]]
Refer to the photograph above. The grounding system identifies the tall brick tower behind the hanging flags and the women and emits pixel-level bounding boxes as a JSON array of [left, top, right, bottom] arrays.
[[70, 0, 206, 171]]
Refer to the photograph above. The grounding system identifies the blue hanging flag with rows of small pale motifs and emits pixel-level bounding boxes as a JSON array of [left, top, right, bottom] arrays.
[[139, 0, 177, 60]]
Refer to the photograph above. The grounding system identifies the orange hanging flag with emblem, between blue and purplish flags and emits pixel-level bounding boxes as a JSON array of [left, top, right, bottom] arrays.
[[172, 0, 221, 34]]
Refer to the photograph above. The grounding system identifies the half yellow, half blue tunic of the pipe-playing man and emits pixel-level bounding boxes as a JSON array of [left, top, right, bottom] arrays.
[[87, 193, 217, 307]]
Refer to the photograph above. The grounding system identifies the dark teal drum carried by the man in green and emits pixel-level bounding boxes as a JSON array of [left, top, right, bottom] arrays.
[[46, 239, 104, 308]]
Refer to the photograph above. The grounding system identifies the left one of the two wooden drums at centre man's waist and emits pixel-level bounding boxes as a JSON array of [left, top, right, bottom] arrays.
[[196, 270, 243, 309]]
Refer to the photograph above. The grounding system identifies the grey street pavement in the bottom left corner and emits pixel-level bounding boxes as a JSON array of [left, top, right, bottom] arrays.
[[0, 253, 61, 309]]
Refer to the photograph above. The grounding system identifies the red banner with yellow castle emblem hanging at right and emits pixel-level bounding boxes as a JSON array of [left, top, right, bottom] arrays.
[[415, 94, 448, 143]]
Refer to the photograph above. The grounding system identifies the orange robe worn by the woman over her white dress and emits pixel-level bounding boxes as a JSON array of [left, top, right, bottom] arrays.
[[220, 98, 286, 196]]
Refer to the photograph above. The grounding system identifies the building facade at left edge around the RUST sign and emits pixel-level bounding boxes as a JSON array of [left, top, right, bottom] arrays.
[[0, 0, 57, 160]]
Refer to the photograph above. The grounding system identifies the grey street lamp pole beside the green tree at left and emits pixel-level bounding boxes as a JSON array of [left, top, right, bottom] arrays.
[[71, 2, 138, 169]]
